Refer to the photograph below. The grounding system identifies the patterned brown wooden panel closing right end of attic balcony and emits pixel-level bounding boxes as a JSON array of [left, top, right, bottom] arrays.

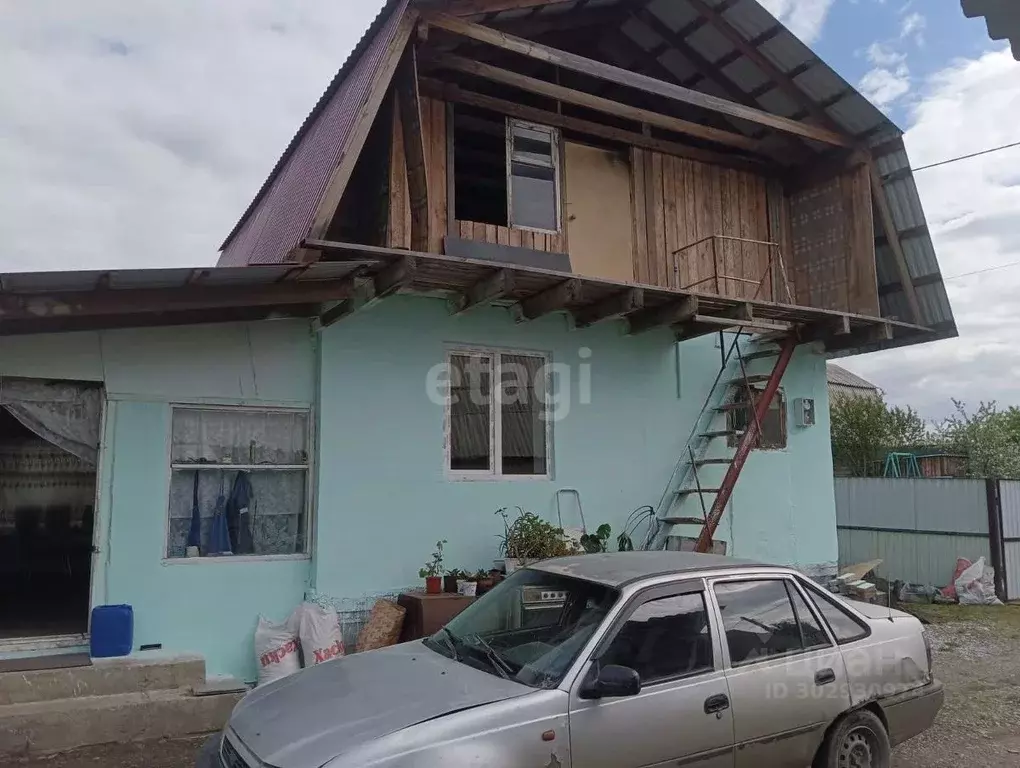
[[787, 165, 880, 316]]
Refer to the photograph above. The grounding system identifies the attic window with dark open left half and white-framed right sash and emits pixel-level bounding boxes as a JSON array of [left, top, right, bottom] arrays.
[[453, 105, 560, 233]]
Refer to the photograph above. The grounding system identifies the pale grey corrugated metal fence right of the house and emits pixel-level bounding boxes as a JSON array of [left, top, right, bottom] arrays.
[[835, 477, 991, 597]]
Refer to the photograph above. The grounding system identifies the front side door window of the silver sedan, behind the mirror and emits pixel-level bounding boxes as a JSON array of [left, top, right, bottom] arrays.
[[599, 592, 714, 685]]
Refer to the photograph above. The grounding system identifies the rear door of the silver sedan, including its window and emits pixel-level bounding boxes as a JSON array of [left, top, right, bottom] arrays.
[[711, 576, 850, 768]]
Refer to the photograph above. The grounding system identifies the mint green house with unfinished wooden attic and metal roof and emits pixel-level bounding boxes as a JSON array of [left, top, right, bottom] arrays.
[[0, 0, 956, 679]]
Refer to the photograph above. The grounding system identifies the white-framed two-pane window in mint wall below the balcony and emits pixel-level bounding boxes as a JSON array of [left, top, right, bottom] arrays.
[[447, 351, 549, 476]]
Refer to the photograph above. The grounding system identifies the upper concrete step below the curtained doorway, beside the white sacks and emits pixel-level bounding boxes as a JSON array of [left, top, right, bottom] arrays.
[[0, 656, 206, 706]]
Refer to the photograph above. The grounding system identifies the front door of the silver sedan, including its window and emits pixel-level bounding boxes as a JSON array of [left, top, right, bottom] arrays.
[[569, 580, 733, 768]]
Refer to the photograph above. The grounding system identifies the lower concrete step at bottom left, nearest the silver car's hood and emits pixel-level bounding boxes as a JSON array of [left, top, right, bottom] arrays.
[[0, 690, 241, 754]]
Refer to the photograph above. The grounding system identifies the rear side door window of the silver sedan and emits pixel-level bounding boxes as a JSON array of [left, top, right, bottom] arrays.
[[715, 579, 829, 666]]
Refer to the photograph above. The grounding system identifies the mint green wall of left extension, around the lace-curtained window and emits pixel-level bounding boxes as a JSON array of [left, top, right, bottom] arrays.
[[0, 321, 315, 679]]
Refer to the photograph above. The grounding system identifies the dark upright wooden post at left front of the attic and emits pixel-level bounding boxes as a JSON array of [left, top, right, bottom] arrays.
[[394, 45, 428, 251]]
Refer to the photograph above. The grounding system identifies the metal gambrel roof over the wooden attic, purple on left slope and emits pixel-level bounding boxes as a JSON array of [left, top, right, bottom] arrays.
[[219, 0, 957, 344]]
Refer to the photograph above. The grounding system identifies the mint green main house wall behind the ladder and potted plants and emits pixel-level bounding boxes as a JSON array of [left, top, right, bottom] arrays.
[[313, 297, 836, 598]]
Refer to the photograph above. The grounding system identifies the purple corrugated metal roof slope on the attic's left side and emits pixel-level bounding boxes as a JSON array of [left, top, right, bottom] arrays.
[[219, 0, 410, 266]]
